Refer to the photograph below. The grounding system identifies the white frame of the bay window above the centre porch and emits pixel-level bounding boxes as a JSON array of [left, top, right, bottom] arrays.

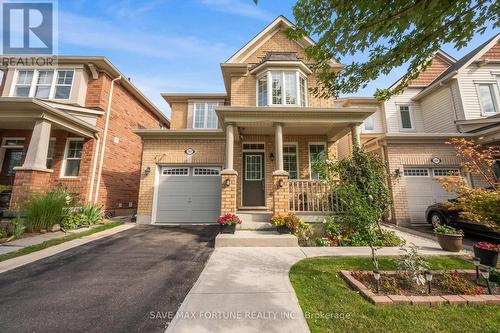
[[255, 68, 308, 107]]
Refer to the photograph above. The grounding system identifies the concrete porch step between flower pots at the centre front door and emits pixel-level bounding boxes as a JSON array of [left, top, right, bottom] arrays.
[[215, 230, 299, 247]]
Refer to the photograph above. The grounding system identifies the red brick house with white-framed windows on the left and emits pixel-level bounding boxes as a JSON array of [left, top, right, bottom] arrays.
[[0, 56, 169, 214]]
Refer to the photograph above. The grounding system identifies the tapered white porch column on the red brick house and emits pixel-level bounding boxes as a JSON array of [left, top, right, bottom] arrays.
[[21, 119, 51, 170]]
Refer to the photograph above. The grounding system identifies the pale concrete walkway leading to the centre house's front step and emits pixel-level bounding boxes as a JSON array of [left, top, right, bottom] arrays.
[[166, 224, 466, 333]]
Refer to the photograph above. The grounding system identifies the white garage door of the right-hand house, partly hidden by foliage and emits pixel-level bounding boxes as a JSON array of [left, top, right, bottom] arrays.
[[404, 168, 460, 223]]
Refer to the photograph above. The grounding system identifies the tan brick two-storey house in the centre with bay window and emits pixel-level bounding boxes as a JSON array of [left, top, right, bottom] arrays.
[[135, 16, 376, 223]]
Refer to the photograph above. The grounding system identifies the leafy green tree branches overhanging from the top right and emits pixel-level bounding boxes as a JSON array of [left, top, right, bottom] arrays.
[[287, 0, 500, 99]]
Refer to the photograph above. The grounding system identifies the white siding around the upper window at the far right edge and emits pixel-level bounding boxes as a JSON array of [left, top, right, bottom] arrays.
[[458, 64, 500, 119]]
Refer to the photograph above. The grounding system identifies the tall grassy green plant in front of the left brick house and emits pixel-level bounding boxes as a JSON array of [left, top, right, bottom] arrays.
[[25, 189, 71, 232]]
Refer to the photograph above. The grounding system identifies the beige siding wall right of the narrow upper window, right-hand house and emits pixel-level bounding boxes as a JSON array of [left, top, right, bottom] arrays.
[[420, 85, 457, 133]]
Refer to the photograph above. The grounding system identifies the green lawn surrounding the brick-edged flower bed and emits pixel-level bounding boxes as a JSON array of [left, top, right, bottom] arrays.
[[290, 256, 500, 333]]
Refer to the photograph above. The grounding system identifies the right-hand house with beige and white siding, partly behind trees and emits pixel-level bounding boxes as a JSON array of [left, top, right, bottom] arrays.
[[339, 34, 500, 225]]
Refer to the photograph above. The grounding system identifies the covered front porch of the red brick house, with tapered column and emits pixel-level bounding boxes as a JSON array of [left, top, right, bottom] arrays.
[[0, 98, 99, 210]]
